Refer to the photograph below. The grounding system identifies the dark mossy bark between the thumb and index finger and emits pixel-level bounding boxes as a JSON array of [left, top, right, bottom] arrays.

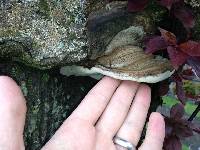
[[0, 63, 97, 150]]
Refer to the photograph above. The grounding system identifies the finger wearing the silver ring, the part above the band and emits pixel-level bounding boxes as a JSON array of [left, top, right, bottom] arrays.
[[117, 84, 151, 145]]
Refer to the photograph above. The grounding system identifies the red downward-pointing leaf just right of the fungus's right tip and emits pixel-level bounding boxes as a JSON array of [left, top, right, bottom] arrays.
[[167, 46, 189, 69]]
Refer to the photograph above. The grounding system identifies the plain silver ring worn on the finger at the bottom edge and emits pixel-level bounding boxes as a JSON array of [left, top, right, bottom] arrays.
[[113, 136, 136, 150]]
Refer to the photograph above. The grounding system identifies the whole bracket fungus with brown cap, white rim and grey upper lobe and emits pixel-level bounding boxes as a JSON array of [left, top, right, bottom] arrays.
[[60, 27, 174, 83]]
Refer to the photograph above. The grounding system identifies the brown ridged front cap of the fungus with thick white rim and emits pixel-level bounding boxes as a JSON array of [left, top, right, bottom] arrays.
[[93, 45, 174, 83]]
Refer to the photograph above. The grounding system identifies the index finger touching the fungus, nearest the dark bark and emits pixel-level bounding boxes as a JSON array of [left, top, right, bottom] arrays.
[[69, 77, 120, 124]]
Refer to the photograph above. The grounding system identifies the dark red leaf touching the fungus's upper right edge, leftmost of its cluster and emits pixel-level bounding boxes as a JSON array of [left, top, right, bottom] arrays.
[[145, 36, 167, 53]]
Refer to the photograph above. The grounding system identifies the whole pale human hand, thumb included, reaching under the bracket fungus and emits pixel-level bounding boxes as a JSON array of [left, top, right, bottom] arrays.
[[0, 77, 165, 150]]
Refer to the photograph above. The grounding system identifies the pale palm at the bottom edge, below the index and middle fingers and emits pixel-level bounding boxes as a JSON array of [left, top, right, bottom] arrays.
[[43, 119, 117, 150]]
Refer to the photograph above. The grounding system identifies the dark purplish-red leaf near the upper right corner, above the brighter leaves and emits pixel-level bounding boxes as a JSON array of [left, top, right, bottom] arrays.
[[173, 6, 195, 28]]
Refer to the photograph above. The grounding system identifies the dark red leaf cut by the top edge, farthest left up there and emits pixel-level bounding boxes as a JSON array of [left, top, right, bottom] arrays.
[[128, 0, 148, 12]]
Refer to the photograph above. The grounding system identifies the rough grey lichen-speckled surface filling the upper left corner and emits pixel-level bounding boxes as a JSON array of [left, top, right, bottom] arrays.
[[0, 0, 87, 68]]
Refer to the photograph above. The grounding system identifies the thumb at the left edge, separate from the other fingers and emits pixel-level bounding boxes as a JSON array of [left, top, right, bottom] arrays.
[[0, 76, 26, 150]]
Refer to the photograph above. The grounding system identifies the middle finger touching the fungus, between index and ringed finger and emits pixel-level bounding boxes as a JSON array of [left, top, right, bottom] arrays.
[[96, 81, 139, 138]]
